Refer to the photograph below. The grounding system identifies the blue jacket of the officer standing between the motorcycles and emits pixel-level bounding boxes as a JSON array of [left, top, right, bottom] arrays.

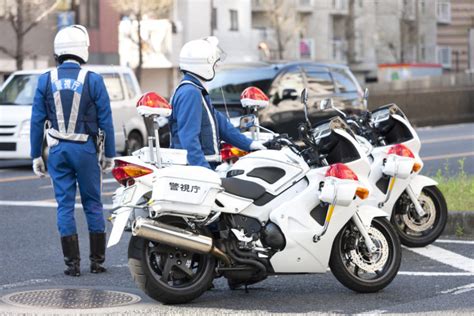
[[169, 74, 252, 168]]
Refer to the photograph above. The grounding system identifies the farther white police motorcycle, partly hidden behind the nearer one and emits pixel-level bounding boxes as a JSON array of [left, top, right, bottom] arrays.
[[320, 94, 448, 247]]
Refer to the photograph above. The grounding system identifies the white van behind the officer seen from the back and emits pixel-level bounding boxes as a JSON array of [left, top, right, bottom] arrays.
[[0, 65, 147, 159]]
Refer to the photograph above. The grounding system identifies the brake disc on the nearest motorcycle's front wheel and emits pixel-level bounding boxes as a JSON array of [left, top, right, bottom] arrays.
[[349, 227, 389, 273]]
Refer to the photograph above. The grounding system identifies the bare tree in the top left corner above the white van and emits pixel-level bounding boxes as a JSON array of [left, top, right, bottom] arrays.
[[0, 0, 61, 70]]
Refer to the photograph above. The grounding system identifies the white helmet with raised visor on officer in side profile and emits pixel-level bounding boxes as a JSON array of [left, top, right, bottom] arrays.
[[179, 36, 225, 81]]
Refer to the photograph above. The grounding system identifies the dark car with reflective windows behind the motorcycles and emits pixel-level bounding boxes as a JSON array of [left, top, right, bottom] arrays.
[[208, 62, 364, 136]]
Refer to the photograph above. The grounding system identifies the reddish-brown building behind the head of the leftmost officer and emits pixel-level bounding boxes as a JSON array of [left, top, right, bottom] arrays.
[[0, 0, 120, 83]]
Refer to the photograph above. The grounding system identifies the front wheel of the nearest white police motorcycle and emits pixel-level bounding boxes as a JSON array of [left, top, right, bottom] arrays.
[[329, 217, 401, 293]]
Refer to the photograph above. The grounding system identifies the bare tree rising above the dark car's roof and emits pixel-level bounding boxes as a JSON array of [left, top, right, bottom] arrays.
[[260, 0, 301, 59]]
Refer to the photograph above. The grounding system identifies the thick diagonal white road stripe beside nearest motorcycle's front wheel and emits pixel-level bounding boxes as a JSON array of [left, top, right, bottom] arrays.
[[406, 245, 474, 273]]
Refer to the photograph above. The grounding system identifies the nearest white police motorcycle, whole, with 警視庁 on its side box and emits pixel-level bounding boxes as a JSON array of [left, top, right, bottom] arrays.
[[108, 89, 401, 304]]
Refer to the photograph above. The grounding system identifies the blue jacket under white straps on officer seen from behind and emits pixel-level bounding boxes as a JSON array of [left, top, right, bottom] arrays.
[[30, 62, 115, 158]]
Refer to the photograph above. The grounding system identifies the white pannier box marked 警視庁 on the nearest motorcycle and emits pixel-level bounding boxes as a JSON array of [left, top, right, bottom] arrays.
[[152, 166, 223, 216]]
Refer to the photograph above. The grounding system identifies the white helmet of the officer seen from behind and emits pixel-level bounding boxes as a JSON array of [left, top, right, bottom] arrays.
[[54, 25, 89, 63]]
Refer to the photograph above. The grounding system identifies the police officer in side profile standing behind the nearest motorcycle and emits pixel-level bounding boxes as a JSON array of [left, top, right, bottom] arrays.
[[169, 36, 266, 169]]
